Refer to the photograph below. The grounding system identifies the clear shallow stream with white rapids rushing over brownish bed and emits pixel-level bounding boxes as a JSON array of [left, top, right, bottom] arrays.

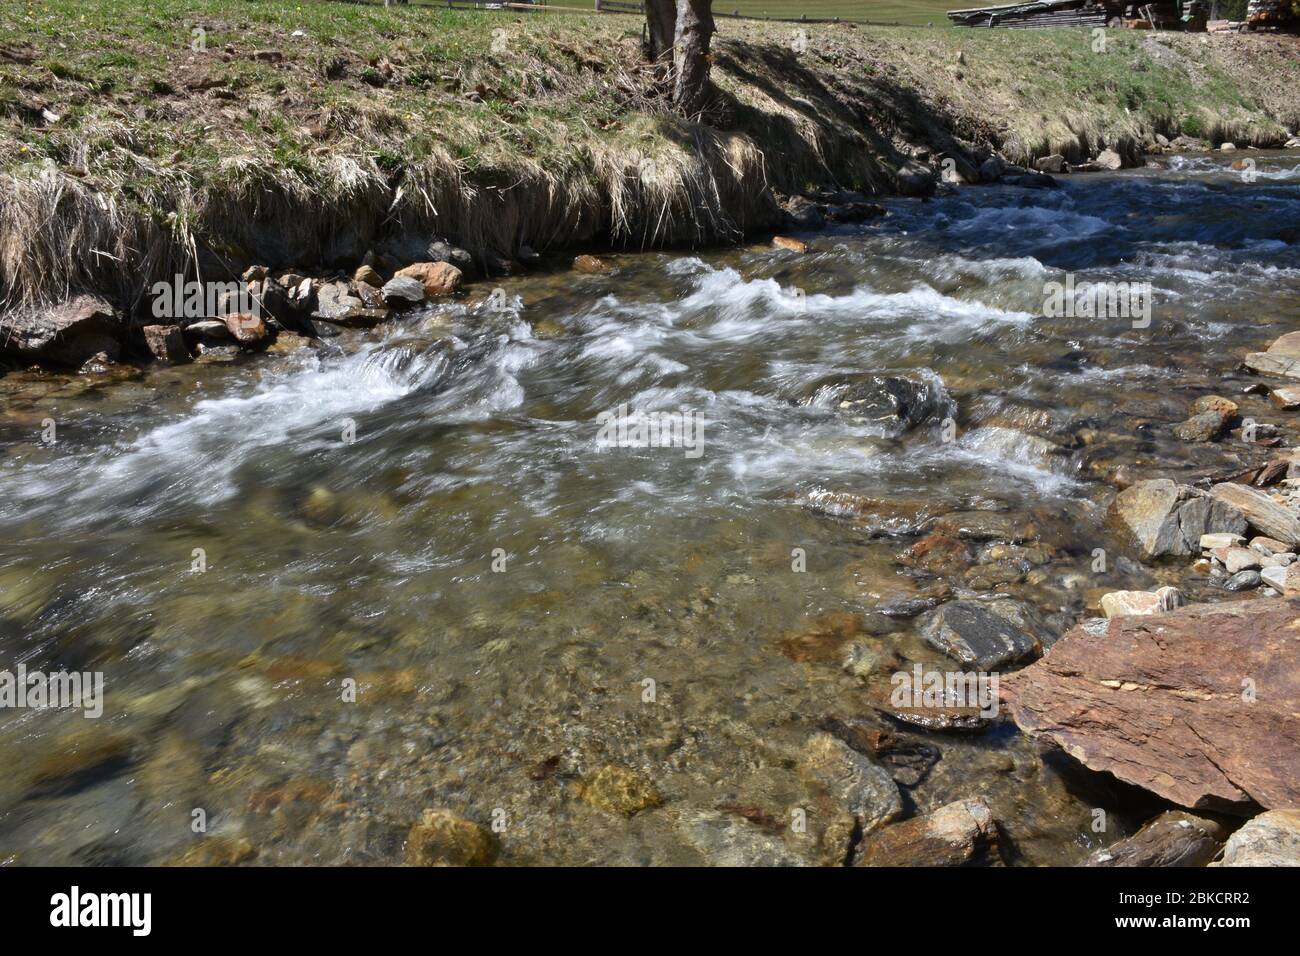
[[0, 153, 1300, 864]]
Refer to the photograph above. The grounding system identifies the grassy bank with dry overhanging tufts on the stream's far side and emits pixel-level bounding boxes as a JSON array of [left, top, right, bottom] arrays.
[[0, 0, 1300, 307]]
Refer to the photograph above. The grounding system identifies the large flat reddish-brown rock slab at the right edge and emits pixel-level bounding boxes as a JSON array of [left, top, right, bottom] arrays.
[[1001, 597, 1300, 813]]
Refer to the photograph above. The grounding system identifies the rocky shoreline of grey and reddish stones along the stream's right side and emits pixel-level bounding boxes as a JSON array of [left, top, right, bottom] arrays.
[[783, 325, 1300, 866]]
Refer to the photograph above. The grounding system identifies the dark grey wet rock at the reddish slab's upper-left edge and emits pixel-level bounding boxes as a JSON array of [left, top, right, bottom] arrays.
[[920, 600, 1043, 671]]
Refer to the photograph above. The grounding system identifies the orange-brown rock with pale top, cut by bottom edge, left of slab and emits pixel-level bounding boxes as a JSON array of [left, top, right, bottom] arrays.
[[853, 797, 1002, 866]]
